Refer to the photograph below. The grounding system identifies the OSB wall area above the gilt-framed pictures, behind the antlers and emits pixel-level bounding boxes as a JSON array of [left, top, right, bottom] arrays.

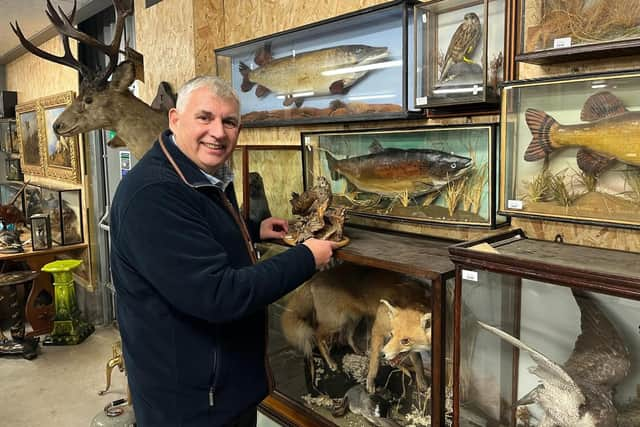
[[6, 37, 78, 104]]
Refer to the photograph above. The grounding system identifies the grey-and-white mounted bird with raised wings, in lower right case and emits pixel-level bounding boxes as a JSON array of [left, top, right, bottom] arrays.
[[478, 291, 631, 427]]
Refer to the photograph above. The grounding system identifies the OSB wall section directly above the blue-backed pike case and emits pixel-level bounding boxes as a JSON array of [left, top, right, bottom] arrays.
[[224, 0, 386, 45]]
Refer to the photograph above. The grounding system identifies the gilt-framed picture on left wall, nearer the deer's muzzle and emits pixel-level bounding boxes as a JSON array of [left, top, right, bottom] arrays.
[[39, 91, 80, 182]]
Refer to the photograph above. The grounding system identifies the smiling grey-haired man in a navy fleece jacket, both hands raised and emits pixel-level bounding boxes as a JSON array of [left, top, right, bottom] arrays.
[[111, 77, 334, 427]]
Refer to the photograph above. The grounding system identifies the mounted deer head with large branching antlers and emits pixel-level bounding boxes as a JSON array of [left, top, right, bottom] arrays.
[[11, 0, 168, 159]]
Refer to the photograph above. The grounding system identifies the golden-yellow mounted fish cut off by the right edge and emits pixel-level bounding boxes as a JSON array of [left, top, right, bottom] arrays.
[[524, 92, 640, 174]]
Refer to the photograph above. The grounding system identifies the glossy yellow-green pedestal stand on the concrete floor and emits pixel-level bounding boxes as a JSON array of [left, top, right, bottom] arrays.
[[42, 259, 95, 345]]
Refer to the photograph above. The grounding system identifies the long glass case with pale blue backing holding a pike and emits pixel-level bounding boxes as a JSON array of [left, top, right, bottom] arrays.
[[215, 1, 421, 127]]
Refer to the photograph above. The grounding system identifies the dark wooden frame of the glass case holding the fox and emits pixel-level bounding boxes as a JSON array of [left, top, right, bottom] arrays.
[[259, 226, 455, 426]]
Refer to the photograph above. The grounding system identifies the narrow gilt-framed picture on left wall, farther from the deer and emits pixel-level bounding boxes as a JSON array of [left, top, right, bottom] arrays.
[[16, 101, 45, 176]]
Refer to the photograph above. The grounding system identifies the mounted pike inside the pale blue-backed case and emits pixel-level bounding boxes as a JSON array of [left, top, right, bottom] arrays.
[[240, 44, 389, 107]]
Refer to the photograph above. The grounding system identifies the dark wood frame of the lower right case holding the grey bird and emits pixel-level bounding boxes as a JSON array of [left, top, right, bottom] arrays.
[[449, 229, 640, 427]]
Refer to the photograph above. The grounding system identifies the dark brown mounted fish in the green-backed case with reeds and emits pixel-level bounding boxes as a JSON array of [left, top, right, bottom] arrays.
[[326, 147, 473, 197]]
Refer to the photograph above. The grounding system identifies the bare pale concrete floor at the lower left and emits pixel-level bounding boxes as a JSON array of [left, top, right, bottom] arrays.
[[0, 327, 278, 427]]
